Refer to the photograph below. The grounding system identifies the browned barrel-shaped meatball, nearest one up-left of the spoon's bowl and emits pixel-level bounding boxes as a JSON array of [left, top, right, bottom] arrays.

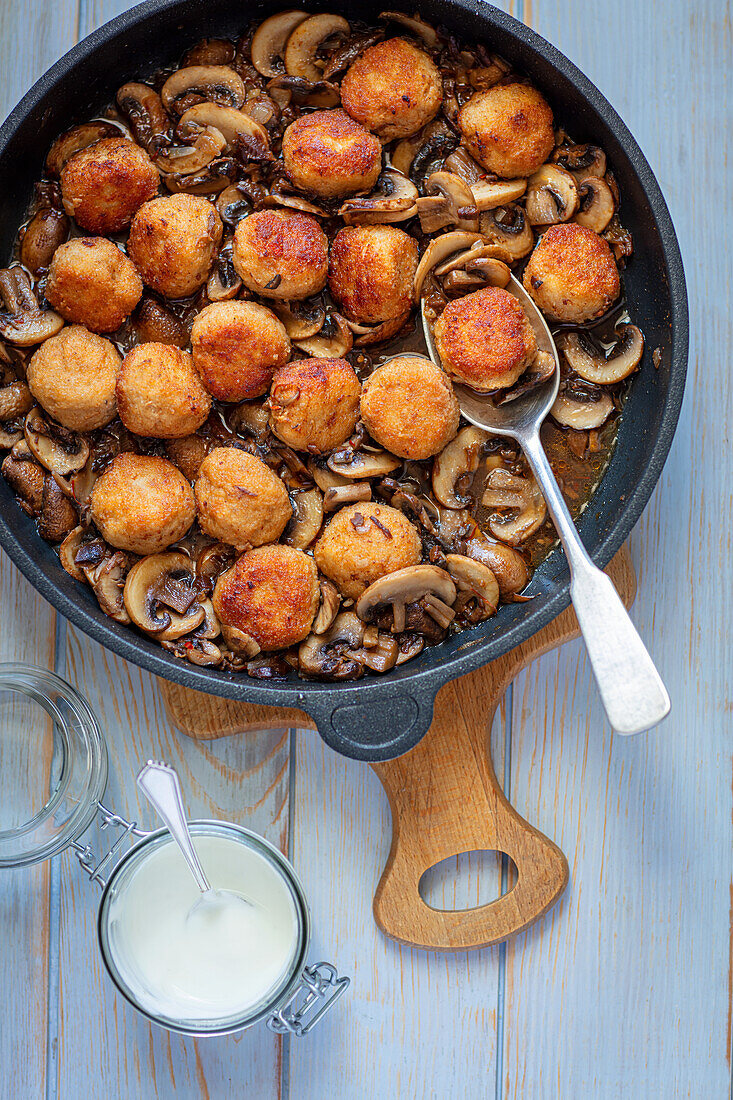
[[328, 226, 417, 325]]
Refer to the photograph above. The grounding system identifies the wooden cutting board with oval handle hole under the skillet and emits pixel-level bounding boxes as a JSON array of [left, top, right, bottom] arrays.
[[158, 547, 636, 952]]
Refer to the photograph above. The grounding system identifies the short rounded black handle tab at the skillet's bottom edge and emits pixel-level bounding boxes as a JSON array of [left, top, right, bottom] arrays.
[[303, 686, 435, 762]]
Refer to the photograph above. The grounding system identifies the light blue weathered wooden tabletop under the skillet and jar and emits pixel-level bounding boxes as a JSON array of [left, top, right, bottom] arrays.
[[0, 0, 733, 1100]]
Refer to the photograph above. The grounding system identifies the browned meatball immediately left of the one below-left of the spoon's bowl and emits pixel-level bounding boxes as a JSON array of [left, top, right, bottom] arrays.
[[270, 359, 361, 454]]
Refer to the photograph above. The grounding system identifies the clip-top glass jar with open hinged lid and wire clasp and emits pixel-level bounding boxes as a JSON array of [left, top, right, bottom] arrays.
[[0, 663, 349, 1036]]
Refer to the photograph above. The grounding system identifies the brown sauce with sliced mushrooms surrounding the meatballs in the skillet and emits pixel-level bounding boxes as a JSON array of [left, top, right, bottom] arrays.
[[0, 12, 643, 679]]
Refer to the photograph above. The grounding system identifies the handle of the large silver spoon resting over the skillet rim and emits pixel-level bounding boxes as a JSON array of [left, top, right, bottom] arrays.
[[519, 432, 670, 734]]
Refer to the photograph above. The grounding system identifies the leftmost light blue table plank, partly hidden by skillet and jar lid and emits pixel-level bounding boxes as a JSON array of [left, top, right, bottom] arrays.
[[0, 0, 77, 1097]]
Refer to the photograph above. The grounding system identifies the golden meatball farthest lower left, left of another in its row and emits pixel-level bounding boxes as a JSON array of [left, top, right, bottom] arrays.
[[91, 451, 196, 554]]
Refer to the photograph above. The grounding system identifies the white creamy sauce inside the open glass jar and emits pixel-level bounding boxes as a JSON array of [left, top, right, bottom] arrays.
[[108, 834, 299, 1023]]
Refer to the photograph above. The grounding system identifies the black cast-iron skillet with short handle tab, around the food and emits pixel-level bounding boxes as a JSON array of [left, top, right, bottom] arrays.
[[0, 0, 688, 760]]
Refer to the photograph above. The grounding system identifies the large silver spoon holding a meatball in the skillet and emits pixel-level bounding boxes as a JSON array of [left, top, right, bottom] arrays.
[[420, 276, 670, 734]]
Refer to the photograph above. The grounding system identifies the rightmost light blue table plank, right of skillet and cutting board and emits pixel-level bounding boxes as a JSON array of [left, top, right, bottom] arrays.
[[503, 0, 733, 1098]]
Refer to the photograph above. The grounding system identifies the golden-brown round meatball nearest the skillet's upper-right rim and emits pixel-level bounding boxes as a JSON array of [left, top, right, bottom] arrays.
[[458, 84, 555, 179]]
